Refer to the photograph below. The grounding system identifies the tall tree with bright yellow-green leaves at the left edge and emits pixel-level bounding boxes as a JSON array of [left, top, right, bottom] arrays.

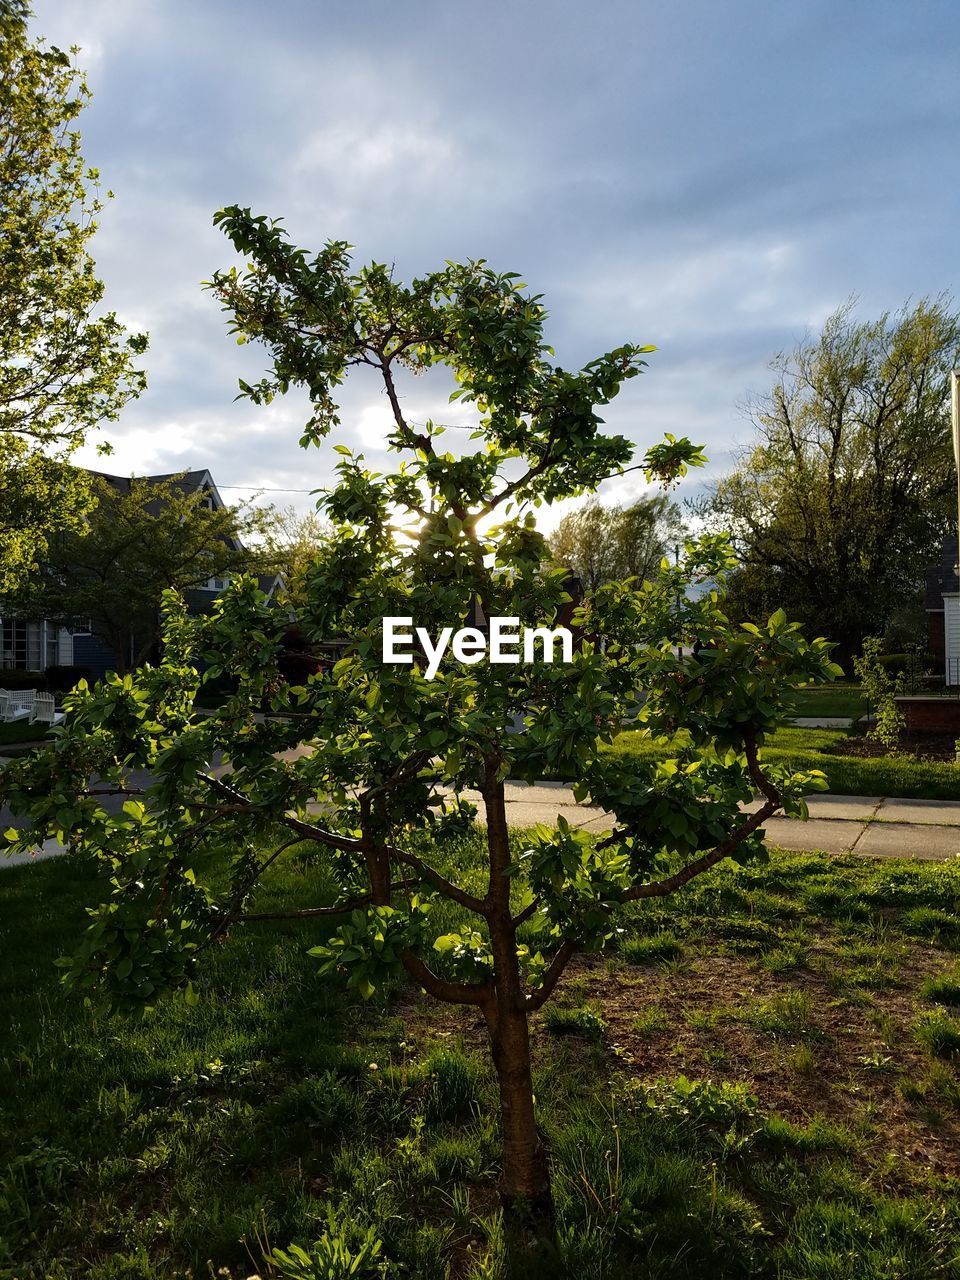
[[0, 0, 146, 590]]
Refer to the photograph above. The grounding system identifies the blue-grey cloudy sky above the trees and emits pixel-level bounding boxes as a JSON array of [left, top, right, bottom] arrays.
[[33, 0, 960, 524]]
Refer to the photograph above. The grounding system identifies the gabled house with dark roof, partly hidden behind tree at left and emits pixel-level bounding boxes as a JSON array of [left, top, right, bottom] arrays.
[[0, 471, 280, 681]]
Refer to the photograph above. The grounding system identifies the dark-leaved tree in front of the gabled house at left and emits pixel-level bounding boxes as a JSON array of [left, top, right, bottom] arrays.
[[4, 472, 270, 672]]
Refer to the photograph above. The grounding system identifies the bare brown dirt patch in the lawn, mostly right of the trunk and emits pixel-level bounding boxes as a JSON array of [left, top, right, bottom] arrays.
[[402, 940, 960, 1187]]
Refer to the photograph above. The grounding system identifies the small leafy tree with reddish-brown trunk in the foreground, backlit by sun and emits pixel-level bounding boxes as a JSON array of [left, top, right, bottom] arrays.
[[3, 225, 836, 1230]]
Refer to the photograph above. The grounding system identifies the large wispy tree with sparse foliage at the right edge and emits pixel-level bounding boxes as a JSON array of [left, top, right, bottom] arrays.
[[707, 298, 960, 659]]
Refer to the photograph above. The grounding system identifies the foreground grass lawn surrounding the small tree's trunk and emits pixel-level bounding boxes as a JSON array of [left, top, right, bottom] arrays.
[[0, 836, 960, 1280]]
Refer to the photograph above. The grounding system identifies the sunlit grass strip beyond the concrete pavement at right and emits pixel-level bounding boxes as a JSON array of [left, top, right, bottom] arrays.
[[604, 728, 960, 800]]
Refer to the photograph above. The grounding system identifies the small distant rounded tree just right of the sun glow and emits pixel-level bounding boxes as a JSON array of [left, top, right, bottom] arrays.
[[549, 493, 684, 591]]
